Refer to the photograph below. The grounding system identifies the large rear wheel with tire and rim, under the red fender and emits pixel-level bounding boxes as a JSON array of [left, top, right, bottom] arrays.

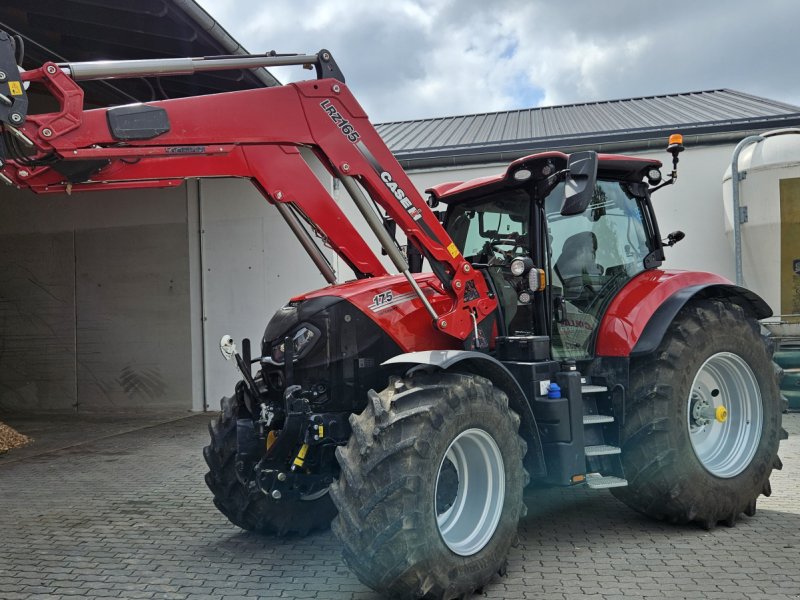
[[612, 299, 783, 529]]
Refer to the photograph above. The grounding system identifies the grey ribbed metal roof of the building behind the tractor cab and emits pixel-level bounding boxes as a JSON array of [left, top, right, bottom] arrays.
[[376, 89, 800, 168]]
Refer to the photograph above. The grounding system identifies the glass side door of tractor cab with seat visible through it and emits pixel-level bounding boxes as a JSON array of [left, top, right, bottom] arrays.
[[545, 181, 653, 359]]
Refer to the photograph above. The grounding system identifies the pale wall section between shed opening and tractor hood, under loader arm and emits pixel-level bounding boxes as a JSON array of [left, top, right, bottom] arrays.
[[199, 179, 326, 410]]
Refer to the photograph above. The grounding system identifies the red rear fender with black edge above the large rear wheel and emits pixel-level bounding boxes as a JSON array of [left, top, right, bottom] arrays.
[[595, 269, 772, 357]]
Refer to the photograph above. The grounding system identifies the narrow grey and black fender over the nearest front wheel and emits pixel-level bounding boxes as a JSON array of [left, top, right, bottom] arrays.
[[383, 350, 547, 477]]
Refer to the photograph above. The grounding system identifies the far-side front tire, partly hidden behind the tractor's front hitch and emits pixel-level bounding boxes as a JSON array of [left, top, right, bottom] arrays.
[[203, 396, 336, 535]]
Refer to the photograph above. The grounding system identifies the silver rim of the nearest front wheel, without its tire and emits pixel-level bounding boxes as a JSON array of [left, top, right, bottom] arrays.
[[433, 429, 506, 556]]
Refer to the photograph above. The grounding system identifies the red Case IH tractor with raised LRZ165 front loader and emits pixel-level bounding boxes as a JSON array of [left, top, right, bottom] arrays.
[[0, 34, 784, 598]]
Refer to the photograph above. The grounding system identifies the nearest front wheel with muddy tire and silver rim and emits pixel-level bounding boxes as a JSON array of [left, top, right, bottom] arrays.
[[331, 372, 527, 600]]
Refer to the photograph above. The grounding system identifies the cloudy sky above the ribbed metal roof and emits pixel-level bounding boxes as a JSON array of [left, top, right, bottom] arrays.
[[199, 0, 800, 122]]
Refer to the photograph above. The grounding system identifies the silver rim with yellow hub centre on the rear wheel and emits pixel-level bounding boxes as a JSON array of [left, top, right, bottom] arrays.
[[687, 352, 764, 479]]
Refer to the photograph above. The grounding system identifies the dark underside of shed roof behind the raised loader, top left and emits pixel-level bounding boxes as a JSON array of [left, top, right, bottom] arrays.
[[0, 0, 278, 105]]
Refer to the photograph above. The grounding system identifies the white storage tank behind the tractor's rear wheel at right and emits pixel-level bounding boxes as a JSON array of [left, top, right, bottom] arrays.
[[722, 129, 800, 315]]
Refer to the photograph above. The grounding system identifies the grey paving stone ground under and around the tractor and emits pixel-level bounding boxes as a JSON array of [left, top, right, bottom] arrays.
[[0, 414, 800, 600]]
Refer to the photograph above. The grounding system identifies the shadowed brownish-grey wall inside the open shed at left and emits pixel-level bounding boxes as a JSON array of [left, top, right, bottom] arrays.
[[0, 188, 192, 411]]
